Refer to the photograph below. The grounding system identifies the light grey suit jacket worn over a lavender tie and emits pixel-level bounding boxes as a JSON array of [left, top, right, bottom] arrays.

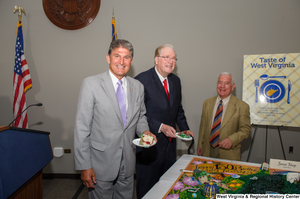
[[74, 71, 149, 181]]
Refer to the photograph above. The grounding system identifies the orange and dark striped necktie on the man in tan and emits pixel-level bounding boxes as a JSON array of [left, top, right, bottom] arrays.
[[209, 100, 223, 148]]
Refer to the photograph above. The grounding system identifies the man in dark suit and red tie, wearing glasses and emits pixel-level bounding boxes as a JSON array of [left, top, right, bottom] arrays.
[[135, 44, 194, 199]]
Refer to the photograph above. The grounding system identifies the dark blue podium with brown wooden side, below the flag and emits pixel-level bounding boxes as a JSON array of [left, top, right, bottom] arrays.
[[0, 126, 53, 199]]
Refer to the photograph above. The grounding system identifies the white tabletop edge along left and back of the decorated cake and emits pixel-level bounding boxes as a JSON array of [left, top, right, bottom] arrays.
[[143, 154, 261, 199]]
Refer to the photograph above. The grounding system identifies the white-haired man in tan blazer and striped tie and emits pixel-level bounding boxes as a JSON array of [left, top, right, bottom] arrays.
[[197, 72, 251, 160]]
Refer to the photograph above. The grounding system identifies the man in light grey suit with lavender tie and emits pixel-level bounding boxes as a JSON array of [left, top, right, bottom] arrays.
[[74, 40, 157, 199]]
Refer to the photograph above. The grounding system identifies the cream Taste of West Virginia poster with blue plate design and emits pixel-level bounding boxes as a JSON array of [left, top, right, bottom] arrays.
[[243, 53, 300, 127]]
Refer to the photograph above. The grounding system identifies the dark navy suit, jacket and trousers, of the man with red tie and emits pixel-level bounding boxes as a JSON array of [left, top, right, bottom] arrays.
[[135, 67, 189, 199]]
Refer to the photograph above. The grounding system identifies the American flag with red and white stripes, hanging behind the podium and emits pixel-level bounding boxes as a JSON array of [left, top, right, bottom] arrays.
[[12, 22, 32, 128]]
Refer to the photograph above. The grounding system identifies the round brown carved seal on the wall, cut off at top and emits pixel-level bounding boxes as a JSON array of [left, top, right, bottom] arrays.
[[43, 0, 101, 30]]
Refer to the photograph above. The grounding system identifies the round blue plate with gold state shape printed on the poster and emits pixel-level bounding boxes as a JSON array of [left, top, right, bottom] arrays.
[[260, 80, 285, 103]]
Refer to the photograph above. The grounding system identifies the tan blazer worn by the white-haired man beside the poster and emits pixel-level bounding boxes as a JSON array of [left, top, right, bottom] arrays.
[[198, 95, 251, 160]]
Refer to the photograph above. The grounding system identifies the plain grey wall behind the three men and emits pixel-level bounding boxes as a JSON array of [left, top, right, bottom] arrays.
[[0, 0, 300, 173]]
